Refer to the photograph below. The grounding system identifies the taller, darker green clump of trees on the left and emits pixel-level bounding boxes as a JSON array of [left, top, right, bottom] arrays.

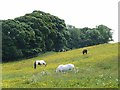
[[2, 11, 67, 61]]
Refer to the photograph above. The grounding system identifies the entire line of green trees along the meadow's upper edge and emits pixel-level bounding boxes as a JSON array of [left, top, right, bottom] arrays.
[[2, 11, 112, 61]]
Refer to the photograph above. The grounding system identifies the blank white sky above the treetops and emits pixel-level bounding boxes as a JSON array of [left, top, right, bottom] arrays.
[[0, 0, 119, 42]]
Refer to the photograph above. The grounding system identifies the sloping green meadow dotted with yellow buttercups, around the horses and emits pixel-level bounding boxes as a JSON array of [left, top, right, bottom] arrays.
[[2, 43, 118, 88]]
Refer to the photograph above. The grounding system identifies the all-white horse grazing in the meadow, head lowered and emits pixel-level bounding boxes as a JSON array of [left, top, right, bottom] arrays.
[[56, 64, 75, 72]]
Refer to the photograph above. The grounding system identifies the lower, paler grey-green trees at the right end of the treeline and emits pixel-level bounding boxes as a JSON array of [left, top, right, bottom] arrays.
[[67, 25, 113, 49]]
